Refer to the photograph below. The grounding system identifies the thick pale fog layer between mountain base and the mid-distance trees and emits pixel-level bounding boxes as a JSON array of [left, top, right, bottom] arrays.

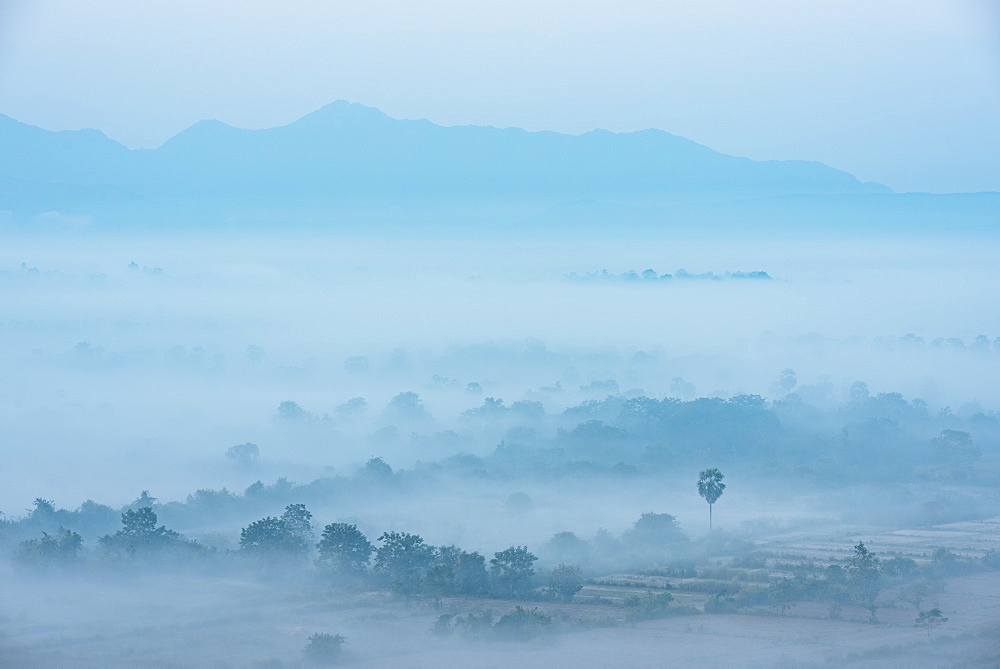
[[0, 230, 1000, 515]]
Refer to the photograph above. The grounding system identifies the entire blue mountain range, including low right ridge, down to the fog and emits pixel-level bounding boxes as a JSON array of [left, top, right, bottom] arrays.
[[0, 102, 1000, 235]]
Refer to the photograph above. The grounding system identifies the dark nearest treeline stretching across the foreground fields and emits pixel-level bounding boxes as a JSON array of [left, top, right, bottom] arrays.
[[13, 504, 1000, 638]]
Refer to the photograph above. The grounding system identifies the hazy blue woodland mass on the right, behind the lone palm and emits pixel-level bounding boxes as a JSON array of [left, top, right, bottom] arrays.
[[278, 386, 1000, 482]]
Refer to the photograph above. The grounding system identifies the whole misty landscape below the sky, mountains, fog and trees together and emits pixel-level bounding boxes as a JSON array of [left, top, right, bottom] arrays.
[[0, 6, 1000, 669]]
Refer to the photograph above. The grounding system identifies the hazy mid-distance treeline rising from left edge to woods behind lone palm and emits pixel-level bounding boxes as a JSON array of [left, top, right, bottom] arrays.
[[0, 384, 1000, 546]]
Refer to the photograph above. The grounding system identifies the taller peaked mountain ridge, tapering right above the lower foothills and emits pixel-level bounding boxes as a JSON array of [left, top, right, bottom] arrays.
[[0, 102, 891, 209]]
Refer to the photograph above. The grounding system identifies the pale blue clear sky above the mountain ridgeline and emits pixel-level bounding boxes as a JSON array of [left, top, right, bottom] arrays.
[[0, 0, 1000, 192]]
